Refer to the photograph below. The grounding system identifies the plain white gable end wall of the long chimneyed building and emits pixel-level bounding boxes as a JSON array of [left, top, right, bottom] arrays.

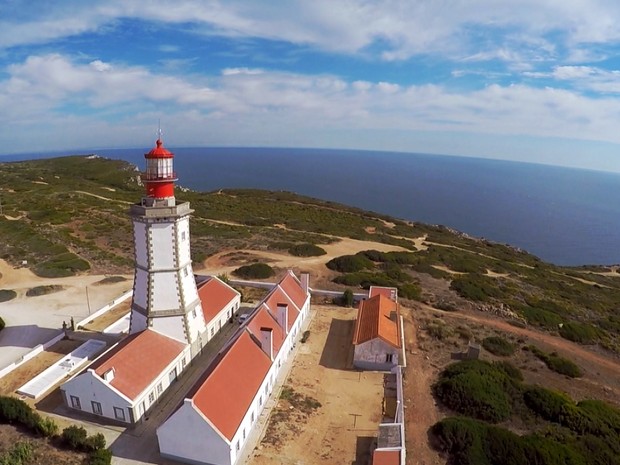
[[157, 399, 232, 465]]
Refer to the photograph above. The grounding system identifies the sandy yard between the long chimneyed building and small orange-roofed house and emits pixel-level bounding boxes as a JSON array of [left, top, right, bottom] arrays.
[[249, 305, 383, 465]]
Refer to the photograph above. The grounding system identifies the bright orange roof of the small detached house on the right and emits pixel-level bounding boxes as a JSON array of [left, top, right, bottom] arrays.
[[353, 294, 400, 348]]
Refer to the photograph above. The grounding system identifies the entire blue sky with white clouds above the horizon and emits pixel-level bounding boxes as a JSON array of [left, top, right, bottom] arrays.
[[0, 0, 620, 172]]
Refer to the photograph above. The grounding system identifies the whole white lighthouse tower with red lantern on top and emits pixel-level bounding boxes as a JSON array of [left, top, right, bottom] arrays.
[[129, 134, 206, 353]]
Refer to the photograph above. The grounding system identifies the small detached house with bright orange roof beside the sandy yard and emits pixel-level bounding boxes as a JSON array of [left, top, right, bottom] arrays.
[[353, 287, 402, 371]]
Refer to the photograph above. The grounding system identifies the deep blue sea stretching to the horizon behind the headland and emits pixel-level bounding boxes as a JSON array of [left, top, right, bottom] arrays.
[[0, 148, 620, 265]]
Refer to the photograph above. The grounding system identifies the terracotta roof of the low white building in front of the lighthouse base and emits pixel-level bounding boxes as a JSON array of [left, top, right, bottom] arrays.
[[90, 329, 186, 400]]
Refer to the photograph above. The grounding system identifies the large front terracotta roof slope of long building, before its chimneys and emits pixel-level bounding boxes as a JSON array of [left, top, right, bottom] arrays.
[[192, 331, 271, 441]]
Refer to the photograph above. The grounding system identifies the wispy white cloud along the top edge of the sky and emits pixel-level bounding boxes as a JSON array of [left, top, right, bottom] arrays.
[[0, 0, 620, 69]]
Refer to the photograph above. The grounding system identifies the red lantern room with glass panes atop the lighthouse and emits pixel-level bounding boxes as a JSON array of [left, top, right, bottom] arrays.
[[142, 138, 177, 199]]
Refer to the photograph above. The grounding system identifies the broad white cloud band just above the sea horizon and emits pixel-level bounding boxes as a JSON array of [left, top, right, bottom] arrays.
[[0, 54, 620, 153]]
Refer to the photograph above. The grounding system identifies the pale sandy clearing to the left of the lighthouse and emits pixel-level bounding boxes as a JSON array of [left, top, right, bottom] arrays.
[[0, 260, 132, 368]]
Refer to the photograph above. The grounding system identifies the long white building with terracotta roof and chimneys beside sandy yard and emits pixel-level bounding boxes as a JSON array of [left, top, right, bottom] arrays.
[[157, 271, 310, 465]]
